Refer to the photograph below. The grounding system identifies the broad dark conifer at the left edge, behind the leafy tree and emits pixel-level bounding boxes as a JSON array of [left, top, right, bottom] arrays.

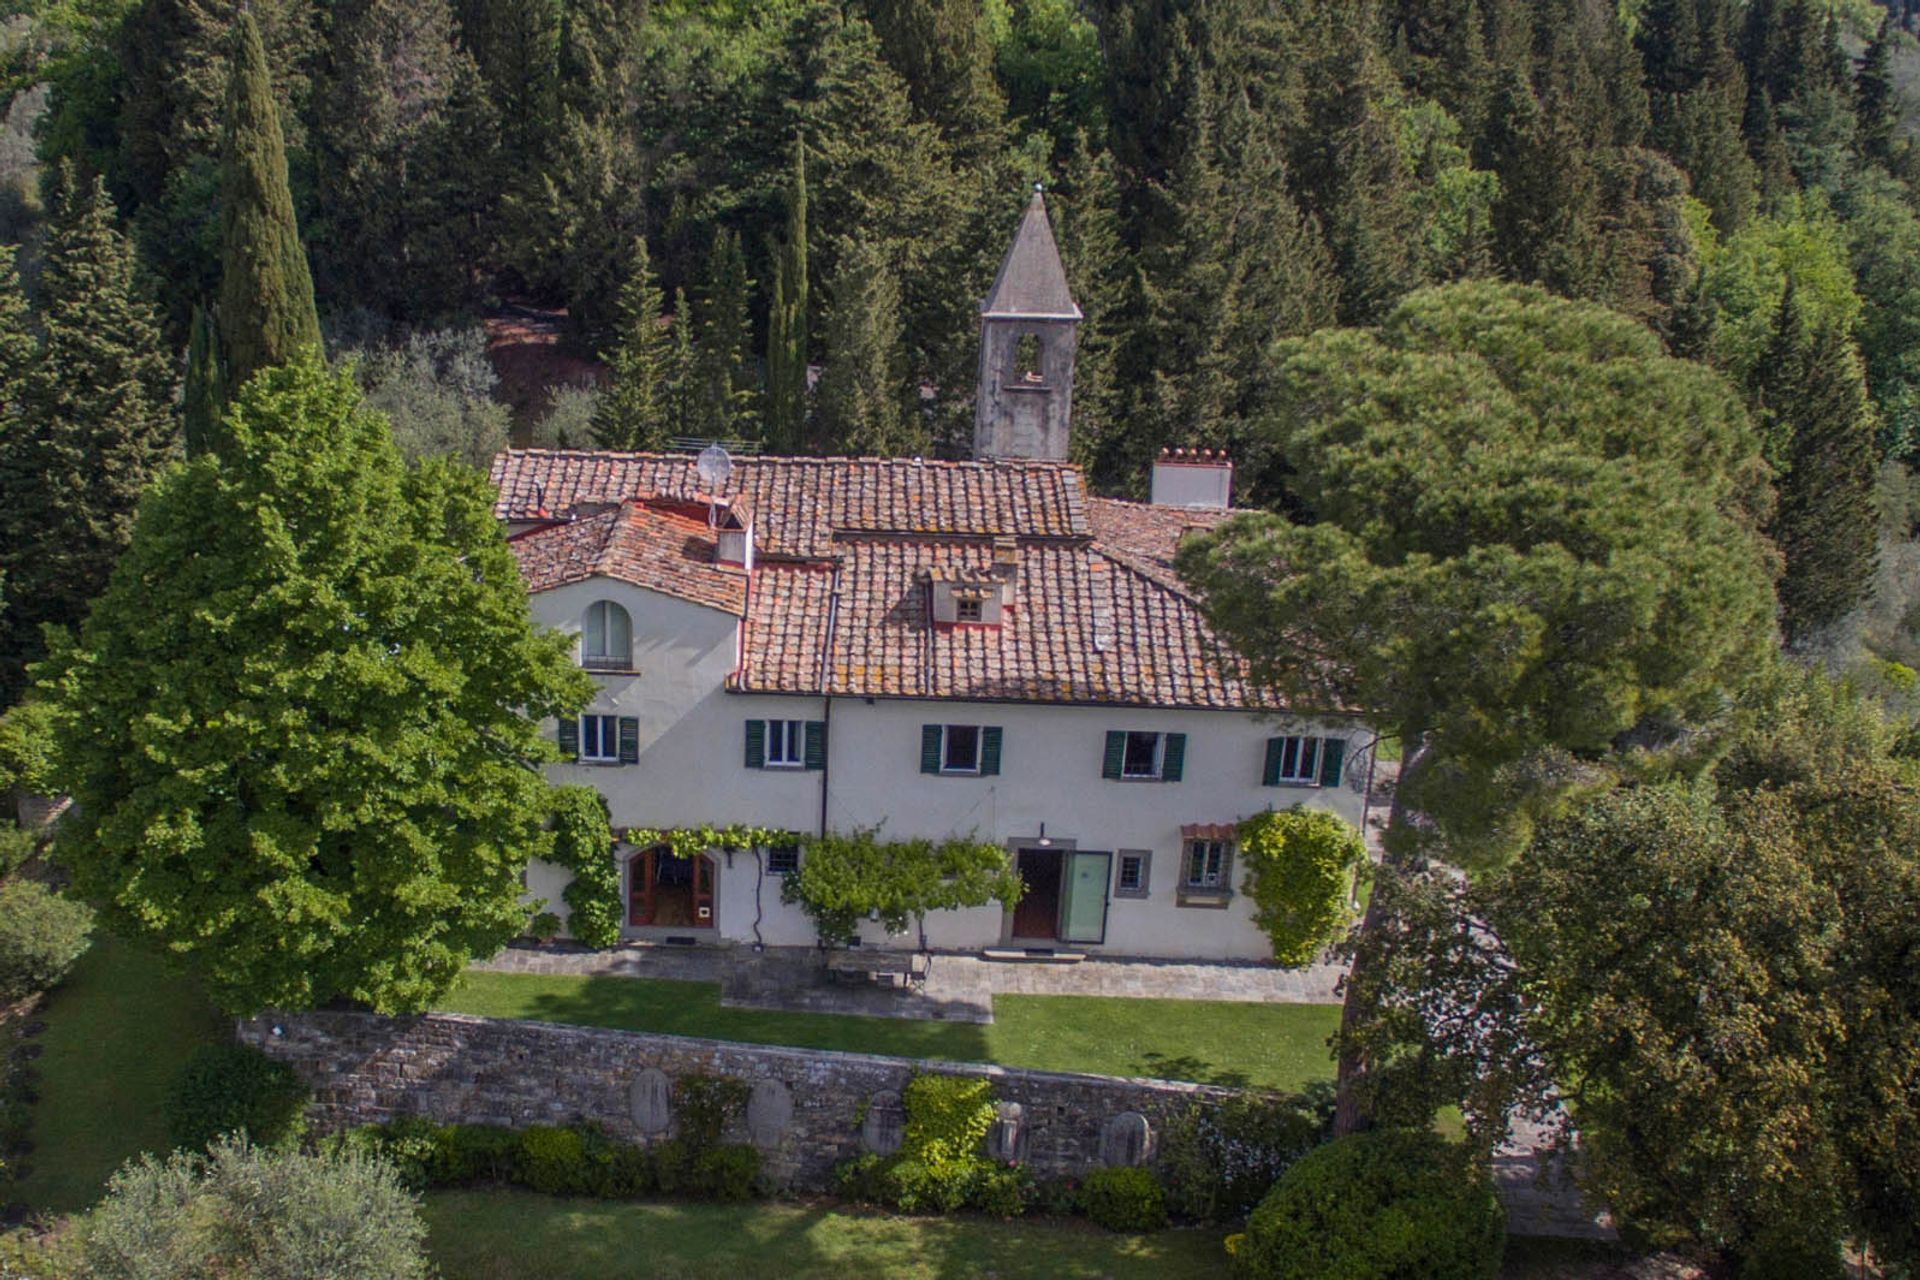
[[0, 165, 177, 700]]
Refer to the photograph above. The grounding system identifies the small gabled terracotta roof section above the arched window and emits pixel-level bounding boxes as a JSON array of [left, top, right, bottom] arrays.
[[507, 499, 747, 616]]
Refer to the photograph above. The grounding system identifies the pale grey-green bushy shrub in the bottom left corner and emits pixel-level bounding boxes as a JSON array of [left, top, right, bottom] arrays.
[[79, 1138, 430, 1280]]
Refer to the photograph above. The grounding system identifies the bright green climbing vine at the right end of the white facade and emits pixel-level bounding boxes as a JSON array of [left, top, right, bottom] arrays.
[[1240, 804, 1367, 969]]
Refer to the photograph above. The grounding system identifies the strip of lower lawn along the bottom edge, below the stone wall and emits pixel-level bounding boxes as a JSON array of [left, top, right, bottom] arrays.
[[426, 1192, 1225, 1280]]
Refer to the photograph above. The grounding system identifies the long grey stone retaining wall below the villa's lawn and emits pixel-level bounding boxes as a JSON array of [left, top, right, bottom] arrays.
[[238, 1013, 1229, 1190]]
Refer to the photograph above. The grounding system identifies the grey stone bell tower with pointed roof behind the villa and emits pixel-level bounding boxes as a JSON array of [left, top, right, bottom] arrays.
[[973, 184, 1081, 462]]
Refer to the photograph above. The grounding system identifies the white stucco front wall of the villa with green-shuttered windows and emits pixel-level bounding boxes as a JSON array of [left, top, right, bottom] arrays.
[[528, 580, 1367, 960]]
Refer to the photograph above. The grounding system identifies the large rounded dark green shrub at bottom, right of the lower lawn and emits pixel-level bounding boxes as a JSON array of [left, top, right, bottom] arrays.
[[1235, 1128, 1505, 1280]]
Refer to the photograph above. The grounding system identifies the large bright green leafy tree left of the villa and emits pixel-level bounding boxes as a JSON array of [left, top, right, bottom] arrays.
[[44, 355, 589, 1013]]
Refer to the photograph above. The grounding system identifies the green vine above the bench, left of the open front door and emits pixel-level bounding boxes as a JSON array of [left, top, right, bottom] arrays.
[[780, 829, 1023, 942]]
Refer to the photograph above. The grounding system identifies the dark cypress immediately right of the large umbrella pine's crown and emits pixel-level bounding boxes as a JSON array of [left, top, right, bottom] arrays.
[[1755, 286, 1880, 647]]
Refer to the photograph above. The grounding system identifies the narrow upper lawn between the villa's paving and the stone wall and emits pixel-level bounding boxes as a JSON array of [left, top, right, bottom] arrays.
[[440, 973, 1340, 1088]]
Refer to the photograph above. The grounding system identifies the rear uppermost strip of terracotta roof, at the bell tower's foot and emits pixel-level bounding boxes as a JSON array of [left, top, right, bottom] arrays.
[[493, 449, 1089, 557]]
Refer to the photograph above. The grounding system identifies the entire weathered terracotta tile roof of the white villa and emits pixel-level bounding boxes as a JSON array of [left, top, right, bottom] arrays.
[[493, 451, 1275, 710]]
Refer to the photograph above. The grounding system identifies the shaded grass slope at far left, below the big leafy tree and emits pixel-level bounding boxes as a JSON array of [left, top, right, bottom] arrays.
[[12, 936, 225, 1213]]
